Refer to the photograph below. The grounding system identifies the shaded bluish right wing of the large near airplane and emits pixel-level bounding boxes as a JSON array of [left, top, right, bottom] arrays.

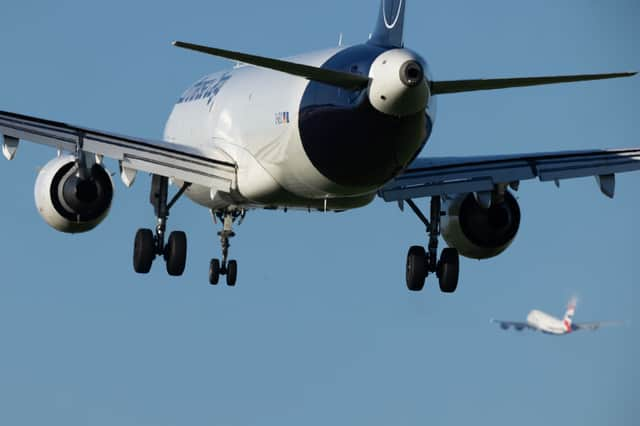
[[378, 148, 640, 201]]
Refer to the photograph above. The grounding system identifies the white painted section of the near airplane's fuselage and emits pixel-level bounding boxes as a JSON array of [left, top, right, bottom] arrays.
[[164, 48, 374, 210]]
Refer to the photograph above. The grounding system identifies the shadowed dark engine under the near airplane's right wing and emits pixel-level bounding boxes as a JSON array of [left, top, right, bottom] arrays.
[[441, 191, 520, 259]]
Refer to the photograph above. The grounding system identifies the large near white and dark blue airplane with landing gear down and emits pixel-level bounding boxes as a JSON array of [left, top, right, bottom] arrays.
[[0, 0, 640, 293]]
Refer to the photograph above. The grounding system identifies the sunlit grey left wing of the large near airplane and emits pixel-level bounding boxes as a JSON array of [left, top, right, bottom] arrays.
[[0, 111, 236, 192]]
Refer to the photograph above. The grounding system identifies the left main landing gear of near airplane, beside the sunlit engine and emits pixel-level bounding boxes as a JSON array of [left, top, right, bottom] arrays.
[[133, 175, 190, 277]]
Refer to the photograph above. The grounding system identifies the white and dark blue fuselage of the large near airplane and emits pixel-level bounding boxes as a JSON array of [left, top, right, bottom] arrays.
[[165, 44, 434, 210]]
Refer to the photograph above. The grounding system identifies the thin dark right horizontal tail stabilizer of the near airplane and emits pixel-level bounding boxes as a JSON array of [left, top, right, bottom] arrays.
[[431, 72, 636, 95]]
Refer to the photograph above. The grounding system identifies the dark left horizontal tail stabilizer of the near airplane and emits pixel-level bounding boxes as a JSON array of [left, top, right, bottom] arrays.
[[173, 41, 369, 90]]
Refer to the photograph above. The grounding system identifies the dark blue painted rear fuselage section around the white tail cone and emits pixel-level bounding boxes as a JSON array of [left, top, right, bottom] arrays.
[[299, 45, 432, 187]]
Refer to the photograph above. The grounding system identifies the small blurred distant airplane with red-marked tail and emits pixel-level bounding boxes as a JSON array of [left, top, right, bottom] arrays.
[[491, 298, 621, 335]]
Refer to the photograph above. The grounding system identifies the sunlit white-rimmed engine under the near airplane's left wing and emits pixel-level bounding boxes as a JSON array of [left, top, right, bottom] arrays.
[[34, 155, 114, 233]]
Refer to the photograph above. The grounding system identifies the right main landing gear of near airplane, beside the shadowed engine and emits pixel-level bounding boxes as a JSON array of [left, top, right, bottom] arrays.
[[406, 197, 460, 293]]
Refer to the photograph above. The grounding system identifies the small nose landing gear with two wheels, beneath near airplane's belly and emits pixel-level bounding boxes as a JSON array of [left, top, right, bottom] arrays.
[[209, 209, 246, 287]]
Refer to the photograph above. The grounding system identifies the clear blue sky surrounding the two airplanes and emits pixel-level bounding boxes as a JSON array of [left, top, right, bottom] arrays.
[[0, 0, 640, 426]]
